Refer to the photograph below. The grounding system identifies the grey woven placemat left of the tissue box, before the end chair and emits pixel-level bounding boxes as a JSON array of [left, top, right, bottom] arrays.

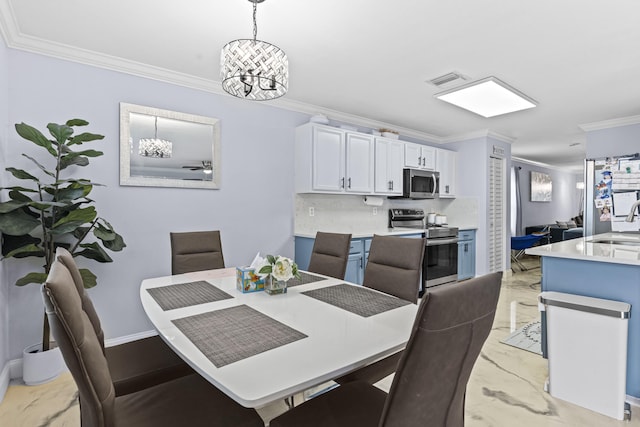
[[147, 280, 233, 311]]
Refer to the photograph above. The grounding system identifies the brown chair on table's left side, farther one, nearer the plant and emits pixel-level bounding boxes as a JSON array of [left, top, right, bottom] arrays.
[[56, 247, 194, 396]]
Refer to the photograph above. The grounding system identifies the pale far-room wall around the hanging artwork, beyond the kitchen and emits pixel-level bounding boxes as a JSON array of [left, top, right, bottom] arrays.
[[513, 160, 582, 232]]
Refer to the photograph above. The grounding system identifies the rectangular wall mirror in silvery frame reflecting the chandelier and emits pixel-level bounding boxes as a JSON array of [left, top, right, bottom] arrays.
[[120, 102, 221, 189]]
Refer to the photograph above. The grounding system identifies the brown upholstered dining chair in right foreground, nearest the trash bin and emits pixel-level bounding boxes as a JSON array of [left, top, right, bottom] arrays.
[[269, 273, 502, 427]]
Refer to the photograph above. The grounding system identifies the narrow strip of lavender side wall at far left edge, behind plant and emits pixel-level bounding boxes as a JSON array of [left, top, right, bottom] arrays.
[[0, 37, 9, 401]]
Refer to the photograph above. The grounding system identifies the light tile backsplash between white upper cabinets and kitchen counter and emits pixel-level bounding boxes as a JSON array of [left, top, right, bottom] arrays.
[[294, 194, 478, 232]]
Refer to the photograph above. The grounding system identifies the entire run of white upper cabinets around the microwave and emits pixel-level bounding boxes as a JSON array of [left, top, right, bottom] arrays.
[[294, 123, 457, 198]]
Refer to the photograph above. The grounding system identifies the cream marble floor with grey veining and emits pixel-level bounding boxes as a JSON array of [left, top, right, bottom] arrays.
[[0, 258, 640, 427]]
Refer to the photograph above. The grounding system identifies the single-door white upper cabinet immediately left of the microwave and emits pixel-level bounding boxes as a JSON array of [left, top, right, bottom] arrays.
[[375, 138, 405, 196]]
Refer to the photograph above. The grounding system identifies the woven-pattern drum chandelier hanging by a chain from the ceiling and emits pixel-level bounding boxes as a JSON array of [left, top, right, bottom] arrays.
[[220, 0, 289, 101]]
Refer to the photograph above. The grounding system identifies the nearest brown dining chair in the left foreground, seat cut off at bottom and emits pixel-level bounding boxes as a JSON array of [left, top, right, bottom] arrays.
[[42, 260, 264, 427]]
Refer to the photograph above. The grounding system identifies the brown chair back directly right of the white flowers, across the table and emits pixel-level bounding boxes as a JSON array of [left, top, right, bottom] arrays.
[[308, 231, 351, 279]]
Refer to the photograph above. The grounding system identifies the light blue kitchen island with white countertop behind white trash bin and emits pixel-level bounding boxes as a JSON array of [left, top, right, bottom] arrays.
[[526, 233, 640, 398]]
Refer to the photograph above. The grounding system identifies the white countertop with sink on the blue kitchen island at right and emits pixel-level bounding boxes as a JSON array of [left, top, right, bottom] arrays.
[[525, 233, 640, 266]]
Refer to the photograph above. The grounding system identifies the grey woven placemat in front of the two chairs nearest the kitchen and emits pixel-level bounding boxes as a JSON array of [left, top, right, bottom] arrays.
[[302, 283, 411, 317]]
